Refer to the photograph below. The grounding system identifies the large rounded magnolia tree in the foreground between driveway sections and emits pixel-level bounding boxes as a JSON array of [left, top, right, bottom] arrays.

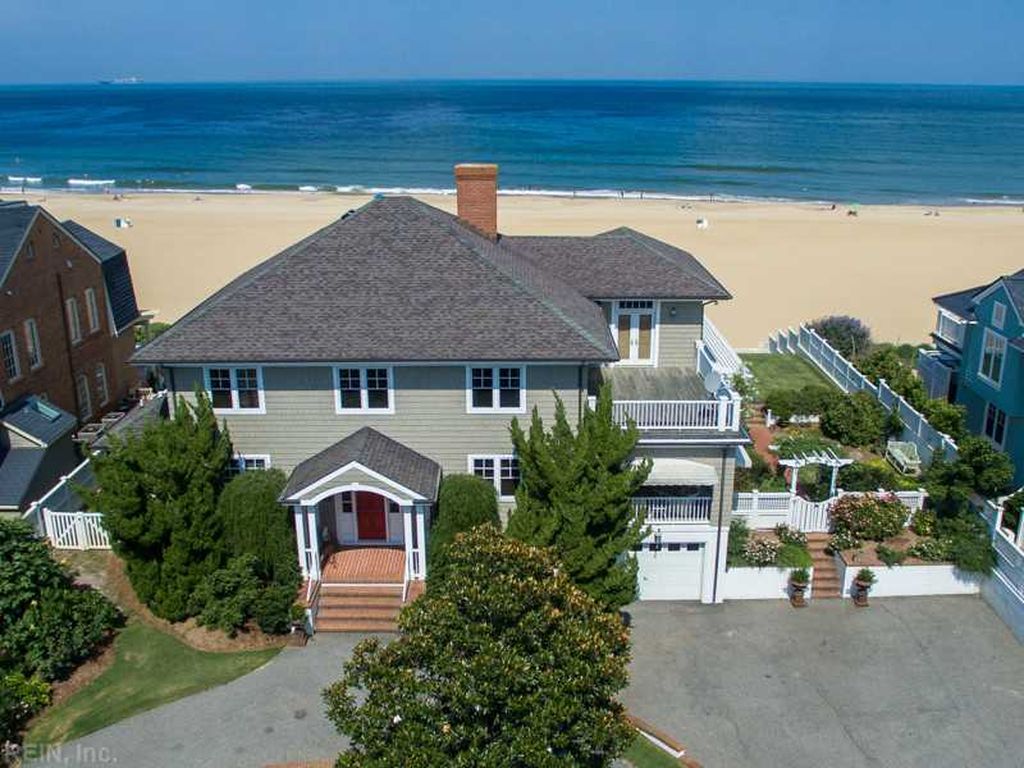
[[324, 525, 633, 768]]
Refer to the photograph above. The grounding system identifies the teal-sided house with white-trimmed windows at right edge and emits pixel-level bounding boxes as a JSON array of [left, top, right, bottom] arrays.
[[919, 269, 1024, 485]]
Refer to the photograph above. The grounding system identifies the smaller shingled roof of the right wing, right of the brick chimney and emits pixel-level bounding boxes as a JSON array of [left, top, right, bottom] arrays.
[[505, 226, 731, 299]]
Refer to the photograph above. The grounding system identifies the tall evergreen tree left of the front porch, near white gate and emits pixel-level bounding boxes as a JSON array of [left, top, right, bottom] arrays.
[[80, 391, 231, 621]]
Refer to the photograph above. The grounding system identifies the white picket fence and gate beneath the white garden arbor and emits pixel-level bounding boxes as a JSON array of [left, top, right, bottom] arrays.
[[732, 488, 928, 534]]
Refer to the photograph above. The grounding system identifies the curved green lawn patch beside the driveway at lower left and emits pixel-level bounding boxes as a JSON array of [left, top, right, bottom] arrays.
[[25, 621, 278, 745]]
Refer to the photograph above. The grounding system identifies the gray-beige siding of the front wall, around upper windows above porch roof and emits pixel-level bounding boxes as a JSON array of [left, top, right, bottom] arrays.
[[168, 365, 586, 473]]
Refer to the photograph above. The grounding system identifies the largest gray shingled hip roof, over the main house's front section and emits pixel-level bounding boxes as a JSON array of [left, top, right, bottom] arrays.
[[133, 197, 618, 364]]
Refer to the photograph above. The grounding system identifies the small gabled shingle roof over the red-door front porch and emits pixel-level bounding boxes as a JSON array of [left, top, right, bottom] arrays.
[[281, 427, 441, 501]]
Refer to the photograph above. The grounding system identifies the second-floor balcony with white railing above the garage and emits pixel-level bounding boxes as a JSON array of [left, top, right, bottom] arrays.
[[590, 367, 740, 432]]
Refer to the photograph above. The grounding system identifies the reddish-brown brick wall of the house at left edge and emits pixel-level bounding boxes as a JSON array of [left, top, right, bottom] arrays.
[[0, 215, 135, 419]]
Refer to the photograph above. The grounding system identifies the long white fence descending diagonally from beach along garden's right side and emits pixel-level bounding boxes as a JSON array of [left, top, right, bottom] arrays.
[[768, 326, 956, 464]]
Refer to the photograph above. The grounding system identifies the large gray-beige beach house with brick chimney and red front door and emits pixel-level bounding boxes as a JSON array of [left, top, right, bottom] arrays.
[[134, 165, 746, 629]]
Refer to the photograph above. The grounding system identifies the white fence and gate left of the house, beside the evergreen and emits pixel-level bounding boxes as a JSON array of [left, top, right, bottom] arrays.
[[23, 459, 111, 550]]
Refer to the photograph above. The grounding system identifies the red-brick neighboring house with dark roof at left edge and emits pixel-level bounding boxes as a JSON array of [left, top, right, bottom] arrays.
[[0, 202, 139, 423]]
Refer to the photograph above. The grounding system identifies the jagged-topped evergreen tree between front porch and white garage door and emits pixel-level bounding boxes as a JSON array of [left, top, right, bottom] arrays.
[[508, 386, 650, 609]]
